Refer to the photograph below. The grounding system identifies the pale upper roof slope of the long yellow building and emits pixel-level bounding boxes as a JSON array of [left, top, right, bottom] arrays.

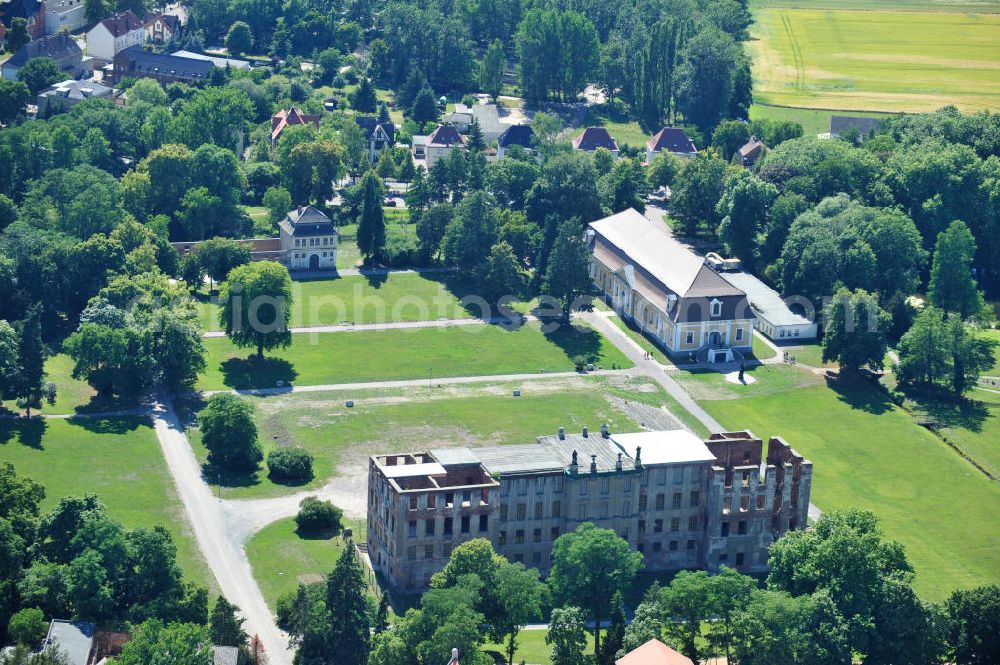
[[590, 208, 705, 296]]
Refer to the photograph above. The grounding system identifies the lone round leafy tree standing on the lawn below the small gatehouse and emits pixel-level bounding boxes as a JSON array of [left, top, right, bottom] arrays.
[[219, 261, 292, 359]]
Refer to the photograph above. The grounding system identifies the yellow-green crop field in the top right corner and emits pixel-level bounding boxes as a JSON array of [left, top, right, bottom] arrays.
[[749, 0, 1000, 112]]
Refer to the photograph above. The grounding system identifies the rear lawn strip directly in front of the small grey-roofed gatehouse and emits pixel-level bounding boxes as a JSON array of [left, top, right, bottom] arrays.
[[198, 273, 479, 330]]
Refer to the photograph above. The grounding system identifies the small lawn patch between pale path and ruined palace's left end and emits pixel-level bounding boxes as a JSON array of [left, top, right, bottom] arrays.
[[245, 517, 365, 611]]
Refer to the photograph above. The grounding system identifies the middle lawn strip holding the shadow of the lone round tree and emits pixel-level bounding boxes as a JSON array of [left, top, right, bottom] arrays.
[[198, 324, 631, 390]]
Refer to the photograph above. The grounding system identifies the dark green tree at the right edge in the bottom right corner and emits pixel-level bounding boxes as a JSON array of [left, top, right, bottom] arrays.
[[945, 584, 1000, 665]]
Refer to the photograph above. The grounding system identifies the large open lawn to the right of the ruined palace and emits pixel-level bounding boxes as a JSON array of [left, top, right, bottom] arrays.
[[700, 368, 1000, 600]]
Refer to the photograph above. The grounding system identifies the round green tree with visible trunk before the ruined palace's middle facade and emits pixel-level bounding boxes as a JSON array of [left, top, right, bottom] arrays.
[[548, 522, 642, 655]]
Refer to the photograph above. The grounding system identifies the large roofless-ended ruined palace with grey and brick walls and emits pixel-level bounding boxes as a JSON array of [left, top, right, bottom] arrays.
[[367, 425, 812, 593]]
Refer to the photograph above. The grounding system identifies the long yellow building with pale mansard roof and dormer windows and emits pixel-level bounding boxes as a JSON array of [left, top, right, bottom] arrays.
[[586, 208, 754, 362]]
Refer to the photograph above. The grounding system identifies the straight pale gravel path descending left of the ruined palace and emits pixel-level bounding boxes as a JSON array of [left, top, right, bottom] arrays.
[[153, 399, 292, 665]]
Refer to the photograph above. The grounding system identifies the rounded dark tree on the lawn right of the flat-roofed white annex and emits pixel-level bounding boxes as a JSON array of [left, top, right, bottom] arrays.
[[823, 288, 892, 372]]
